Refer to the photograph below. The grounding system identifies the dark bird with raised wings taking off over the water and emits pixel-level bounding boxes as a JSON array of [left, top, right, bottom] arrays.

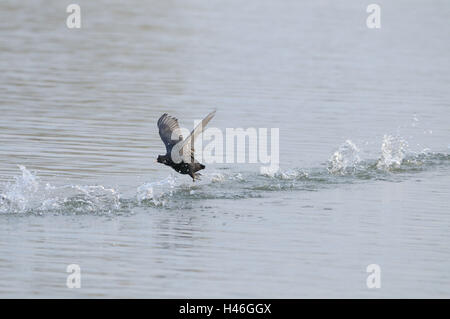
[[157, 111, 216, 182]]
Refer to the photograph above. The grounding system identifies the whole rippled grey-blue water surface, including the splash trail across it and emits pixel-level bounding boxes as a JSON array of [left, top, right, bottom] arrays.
[[0, 0, 450, 298]]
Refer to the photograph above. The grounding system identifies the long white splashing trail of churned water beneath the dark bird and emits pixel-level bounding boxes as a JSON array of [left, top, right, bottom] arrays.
[[0, 135, 450, 214]]
